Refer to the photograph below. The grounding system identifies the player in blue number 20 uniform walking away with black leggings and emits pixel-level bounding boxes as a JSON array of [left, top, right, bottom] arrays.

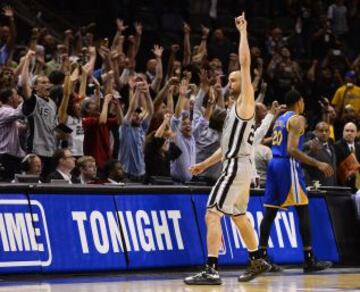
[[259, 90, 333, 272]]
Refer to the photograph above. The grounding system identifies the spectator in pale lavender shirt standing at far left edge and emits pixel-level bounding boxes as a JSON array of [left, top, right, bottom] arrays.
[[0, 88, 25, 181]]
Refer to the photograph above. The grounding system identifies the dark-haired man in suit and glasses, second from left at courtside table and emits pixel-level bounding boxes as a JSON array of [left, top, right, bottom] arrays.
[[46, 148, 75, 184]]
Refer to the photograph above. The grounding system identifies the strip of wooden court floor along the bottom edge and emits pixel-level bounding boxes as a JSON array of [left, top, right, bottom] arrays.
[[0, 268, 360, 292]]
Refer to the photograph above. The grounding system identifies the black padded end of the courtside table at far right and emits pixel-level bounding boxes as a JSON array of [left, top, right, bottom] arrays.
[[324, 193, 360, 265]]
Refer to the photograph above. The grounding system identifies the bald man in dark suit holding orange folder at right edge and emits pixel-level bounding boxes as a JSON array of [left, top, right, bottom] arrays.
[[335, 122, 360, 190]]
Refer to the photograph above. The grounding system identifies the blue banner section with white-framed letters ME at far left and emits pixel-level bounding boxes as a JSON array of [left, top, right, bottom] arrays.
[[0, 194, 41, 274]]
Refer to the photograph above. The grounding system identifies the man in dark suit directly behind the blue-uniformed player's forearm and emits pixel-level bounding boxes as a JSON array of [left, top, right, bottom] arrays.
[[303, 122, 337, 186]]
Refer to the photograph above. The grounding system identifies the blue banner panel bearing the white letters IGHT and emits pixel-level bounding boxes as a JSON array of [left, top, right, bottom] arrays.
[[116, 194, 204, 268]]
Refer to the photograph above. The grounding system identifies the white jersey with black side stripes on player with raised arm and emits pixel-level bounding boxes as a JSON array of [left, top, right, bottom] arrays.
[[221, 103, 255, 160]]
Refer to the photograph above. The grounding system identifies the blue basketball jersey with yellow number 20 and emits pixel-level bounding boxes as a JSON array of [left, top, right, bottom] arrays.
[[272, 111, 304, 157]]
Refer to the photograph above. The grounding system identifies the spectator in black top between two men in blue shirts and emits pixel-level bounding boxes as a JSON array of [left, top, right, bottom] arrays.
[[144, 114, 181, 183]]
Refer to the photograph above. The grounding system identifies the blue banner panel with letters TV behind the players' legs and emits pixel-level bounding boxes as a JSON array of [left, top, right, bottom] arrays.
[[193, 194, 339, 265]]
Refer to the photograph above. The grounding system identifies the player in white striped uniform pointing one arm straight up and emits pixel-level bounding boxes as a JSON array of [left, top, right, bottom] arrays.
[[184, 13, 270, 285]]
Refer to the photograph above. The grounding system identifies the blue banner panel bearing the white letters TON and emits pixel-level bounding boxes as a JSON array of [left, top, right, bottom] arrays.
[[30, 194, 126, 272]]
